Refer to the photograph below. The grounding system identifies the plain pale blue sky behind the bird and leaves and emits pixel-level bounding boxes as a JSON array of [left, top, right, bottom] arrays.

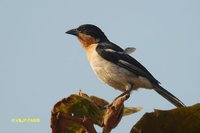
[[0, 0, 200, 133]]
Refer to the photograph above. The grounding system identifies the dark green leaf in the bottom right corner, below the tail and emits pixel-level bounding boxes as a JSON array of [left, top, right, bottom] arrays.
[[131, 104, 200, 133]]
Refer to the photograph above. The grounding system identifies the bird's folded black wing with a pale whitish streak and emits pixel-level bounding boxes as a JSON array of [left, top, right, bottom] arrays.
[[96, 42, 159, 85]]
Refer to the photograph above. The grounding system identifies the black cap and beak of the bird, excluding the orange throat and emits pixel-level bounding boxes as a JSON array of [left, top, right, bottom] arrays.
[[66, 24, 108, 42]]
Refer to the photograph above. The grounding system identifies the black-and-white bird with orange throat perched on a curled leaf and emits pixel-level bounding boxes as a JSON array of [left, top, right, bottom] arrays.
[[65, 24, 186, 107]]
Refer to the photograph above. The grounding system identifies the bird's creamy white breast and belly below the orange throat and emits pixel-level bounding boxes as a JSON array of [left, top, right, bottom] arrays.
[[87, 44, 152, 91]]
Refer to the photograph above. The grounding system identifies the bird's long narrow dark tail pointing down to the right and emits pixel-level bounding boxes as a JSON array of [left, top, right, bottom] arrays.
[[154, 85, 185, 107]]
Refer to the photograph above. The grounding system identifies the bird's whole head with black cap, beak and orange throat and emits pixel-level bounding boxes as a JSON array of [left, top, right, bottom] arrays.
[[66, 24, 109, 47]]
